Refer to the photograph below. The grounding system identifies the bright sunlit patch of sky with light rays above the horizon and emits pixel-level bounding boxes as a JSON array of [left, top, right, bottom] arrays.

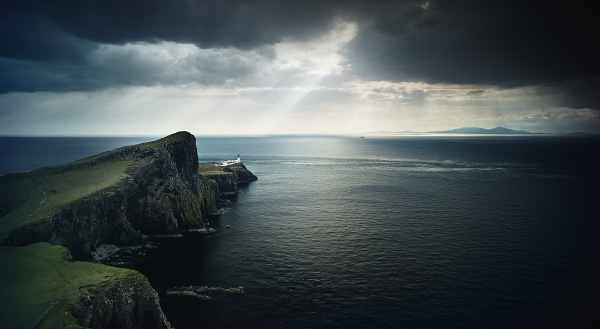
[[0, 19, 600, 135]]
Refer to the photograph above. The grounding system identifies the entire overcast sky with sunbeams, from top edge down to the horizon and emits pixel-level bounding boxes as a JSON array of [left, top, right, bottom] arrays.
[[0, 0, 600, 135]]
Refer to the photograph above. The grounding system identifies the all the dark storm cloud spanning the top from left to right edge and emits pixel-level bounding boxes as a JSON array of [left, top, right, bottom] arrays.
[[0, 0, 600, 108]]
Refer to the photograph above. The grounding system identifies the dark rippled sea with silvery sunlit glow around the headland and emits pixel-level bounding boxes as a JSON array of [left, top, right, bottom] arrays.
[[0, 135, 600, 329]]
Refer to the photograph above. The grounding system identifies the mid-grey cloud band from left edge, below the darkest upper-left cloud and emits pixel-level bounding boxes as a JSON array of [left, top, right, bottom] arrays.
[[0, 44, 267, 92]]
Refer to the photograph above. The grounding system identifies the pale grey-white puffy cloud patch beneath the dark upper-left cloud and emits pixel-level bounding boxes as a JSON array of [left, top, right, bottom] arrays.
[[89, 42, 270, 86]]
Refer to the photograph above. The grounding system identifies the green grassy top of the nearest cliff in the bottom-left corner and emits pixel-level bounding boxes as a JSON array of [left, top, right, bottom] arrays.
[[0, 243, 140, 328]]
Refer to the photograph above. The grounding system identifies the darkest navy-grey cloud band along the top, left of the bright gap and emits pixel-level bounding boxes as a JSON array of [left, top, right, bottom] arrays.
[[0, 0, 346, 59]]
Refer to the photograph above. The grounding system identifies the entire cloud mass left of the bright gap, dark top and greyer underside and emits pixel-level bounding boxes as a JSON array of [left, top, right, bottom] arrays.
[[0, 0, 356, 93]]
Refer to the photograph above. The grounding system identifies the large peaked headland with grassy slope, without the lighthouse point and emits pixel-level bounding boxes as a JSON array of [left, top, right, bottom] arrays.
[[0, 132, 219, 259]]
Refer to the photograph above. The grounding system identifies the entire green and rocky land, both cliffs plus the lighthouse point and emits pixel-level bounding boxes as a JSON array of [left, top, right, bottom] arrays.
[[0, 132, 256, 328]]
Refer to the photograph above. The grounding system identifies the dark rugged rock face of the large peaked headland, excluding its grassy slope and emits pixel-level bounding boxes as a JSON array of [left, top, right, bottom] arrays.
[[4, 132, 219, 259]]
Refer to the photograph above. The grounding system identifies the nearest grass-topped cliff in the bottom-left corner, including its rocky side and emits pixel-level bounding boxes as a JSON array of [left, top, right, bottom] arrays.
[[0, 243, 170, 329]]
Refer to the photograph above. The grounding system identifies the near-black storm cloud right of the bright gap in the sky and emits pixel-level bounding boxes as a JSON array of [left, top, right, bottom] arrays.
[[345, 0, 600, 108]]
